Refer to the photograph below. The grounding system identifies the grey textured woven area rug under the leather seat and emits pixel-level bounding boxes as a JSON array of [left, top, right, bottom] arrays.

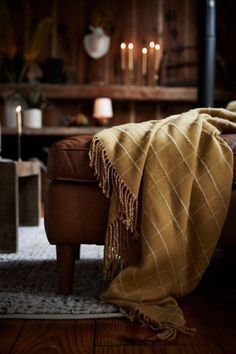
[[0, 220, 121, 319]]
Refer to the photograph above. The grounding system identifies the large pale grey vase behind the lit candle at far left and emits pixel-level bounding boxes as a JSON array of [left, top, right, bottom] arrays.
[[3, 92, 27, 128]]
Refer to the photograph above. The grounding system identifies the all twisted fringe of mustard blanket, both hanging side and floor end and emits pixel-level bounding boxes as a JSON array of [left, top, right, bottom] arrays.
[[89, 133, 195, 342]]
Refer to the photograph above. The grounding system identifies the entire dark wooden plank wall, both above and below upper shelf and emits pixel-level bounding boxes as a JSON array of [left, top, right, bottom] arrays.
[[0, 0, 236, 125]]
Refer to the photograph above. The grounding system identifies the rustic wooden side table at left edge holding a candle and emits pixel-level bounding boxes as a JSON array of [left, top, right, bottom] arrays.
[[0, 159, 41, 253]]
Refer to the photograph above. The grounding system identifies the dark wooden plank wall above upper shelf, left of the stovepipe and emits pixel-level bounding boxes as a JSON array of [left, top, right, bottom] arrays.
[[4, 0, 197, 85]]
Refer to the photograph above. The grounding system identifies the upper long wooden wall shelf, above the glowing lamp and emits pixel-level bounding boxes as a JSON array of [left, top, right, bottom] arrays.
[[0, 84, 236, 102]]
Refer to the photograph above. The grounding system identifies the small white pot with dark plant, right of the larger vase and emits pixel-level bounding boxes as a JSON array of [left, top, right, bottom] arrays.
[[22, 82, 46, 128]]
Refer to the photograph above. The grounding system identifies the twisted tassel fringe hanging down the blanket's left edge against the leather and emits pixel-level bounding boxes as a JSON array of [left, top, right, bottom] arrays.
[[89, 137, 138, 278]]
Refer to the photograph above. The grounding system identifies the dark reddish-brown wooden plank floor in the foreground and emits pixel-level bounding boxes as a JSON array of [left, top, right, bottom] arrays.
[[0, 250, 236, 354]]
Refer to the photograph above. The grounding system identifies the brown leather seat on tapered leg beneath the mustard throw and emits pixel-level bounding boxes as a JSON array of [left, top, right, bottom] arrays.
[[45, 134, 236, 294]]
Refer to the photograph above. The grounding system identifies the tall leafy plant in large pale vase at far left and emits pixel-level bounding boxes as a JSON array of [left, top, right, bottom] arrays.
[[0, 0, 52, 127]]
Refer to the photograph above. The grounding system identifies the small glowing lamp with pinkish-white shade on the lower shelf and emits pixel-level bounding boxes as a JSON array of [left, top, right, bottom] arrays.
[[93, 97, 113, 124]]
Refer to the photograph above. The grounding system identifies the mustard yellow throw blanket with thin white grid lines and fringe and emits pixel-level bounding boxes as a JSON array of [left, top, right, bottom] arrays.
[[90, 109, 236, 340]]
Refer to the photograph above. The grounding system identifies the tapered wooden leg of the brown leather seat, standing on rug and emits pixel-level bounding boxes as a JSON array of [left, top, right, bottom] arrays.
[[56, 245, 76, 295]]
